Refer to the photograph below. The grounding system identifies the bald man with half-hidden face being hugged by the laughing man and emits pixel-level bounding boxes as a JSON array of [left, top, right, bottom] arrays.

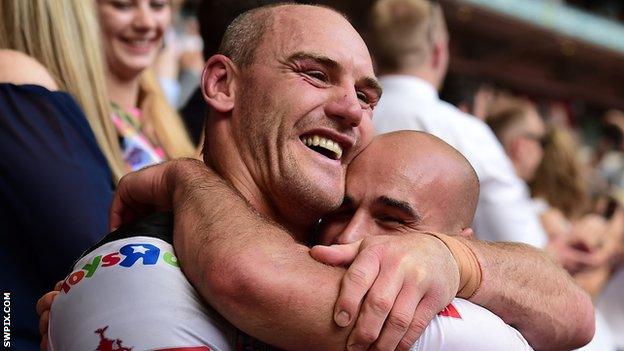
[[311, 131, 531, 351]]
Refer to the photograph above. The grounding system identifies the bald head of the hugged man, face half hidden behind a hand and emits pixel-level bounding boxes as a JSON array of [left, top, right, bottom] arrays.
[[319, 132, 478, 245]]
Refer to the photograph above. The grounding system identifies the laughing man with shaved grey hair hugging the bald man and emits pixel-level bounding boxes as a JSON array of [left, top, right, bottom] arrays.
[[50, 5, 593, 350]]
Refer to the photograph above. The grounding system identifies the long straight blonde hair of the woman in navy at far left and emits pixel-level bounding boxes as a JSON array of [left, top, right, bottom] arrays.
[[0, 0, 126, 182]]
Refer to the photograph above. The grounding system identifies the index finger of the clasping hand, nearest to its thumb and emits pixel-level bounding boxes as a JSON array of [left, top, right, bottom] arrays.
[[334, 250, 380, 327]]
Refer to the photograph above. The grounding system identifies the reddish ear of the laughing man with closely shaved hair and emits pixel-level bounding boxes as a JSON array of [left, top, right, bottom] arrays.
[[201, 55, 238, 113]]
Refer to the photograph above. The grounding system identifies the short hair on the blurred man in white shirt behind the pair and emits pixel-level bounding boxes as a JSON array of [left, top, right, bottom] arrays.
[[370, 0, 447, 73]]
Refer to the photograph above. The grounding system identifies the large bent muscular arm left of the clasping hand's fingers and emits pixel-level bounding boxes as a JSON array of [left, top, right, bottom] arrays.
[[167, 164, 349, 350]]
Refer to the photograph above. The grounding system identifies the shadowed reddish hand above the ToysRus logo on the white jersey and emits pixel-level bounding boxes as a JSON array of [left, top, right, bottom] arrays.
[[109, 159, 207, 231]]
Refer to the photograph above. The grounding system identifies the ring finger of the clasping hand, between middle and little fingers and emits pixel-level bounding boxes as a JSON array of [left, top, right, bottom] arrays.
[[374, 284, 422, 350]]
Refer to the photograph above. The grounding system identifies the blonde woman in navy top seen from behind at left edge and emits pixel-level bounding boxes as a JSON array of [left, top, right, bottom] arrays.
[[0, 0, 118, 350]]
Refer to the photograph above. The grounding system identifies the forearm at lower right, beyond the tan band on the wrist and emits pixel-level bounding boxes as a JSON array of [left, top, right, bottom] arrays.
[[460, 238, 594, 350]]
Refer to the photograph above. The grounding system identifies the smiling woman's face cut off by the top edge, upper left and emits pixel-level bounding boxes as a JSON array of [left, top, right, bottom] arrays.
[[97, 0, 171, 79]]
